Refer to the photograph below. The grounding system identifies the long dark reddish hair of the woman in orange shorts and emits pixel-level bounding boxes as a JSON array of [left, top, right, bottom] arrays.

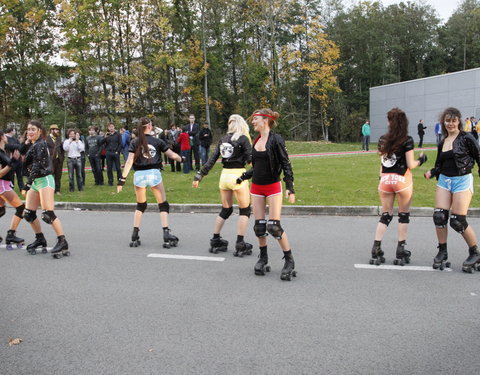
[[378, 108, 408, 157]]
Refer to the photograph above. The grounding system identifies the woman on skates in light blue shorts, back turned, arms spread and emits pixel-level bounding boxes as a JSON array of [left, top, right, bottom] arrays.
[[117, 117, 183, 248]]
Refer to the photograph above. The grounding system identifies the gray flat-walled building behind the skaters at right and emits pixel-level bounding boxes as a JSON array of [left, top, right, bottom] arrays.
[[370, 68, 480, 145]]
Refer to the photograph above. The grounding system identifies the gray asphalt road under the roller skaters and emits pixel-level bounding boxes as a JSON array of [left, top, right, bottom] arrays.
[[0, 209, 480, 375]]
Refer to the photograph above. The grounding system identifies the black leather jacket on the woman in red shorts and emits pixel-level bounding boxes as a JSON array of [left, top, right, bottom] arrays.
[[242, 132, 295, 194]]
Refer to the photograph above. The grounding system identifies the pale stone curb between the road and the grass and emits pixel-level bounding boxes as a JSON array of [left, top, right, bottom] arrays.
[[55, 202, 480, 217]]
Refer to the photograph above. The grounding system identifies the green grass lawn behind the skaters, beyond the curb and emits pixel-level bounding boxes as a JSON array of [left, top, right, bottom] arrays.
[[31, 142, 480, 207]]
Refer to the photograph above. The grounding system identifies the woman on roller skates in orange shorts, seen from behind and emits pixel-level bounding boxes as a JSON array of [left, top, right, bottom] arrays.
[[370, 108, 427, 266]]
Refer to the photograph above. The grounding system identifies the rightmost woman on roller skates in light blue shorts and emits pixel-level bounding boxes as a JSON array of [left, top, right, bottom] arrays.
[[424, 107, 480, 273]]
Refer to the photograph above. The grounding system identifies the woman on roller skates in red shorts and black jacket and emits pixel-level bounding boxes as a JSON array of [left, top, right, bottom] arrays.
[[237, 108, 296, 280]]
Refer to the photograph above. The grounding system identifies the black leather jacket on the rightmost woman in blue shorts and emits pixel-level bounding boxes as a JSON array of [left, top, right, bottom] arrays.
[[430, 131, 480, 180]]
